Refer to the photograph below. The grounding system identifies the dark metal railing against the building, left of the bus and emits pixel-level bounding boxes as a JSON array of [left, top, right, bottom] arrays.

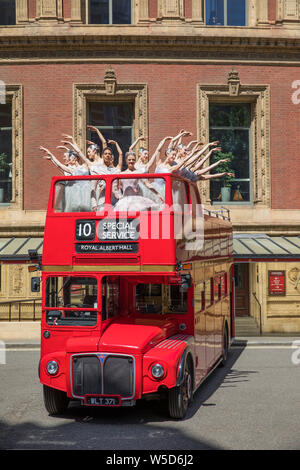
[[0, 298, 42, 322]]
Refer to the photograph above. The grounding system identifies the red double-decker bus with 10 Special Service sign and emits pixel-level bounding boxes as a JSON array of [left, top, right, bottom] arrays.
[[35, 174, 234, 418]]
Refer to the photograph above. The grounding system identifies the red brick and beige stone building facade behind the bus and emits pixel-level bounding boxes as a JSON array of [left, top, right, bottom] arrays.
[[0, 0, 300, 333]]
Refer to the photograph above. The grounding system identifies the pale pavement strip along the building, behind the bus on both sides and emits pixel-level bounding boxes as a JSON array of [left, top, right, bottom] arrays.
[[0, 335, 300, 349]]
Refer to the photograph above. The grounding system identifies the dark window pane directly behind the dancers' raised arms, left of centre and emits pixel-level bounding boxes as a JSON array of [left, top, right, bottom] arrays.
[[88, 101, 134, 163]]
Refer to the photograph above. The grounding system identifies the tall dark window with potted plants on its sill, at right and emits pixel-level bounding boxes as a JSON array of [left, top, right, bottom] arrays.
[[209, 103, 252, 203]]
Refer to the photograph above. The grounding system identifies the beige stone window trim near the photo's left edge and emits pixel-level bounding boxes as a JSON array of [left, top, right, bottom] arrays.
[[6, 85, 23, 209]]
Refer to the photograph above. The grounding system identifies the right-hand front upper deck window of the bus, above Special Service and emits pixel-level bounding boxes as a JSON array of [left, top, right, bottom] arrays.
[[112, 178, 165, 212]]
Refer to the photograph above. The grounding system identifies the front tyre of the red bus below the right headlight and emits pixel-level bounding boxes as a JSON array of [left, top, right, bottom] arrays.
[[168, 361, 193, 419]]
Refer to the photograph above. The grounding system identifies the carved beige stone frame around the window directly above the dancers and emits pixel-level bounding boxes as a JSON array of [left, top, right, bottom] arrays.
[[73, 69, 148, 150]]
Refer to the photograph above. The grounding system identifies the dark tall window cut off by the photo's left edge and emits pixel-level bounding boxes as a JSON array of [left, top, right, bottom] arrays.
[[0, 103, 12, 204]]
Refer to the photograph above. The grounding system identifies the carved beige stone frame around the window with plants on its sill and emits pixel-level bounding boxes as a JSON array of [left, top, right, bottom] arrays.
[[197, 75, 271, 207]]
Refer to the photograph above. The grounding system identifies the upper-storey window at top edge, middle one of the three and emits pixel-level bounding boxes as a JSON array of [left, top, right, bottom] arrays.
[[87, 0, 132, 24]]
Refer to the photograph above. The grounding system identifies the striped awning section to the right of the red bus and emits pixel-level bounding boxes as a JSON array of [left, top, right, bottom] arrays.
[[233, 233, 300, 259]]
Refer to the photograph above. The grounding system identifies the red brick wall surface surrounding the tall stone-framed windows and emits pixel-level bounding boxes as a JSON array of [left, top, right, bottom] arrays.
[[0, 64, 300, 209]]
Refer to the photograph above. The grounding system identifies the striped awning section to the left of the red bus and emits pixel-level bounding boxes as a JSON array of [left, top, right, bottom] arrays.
[[0, 237, 43, 261]]
